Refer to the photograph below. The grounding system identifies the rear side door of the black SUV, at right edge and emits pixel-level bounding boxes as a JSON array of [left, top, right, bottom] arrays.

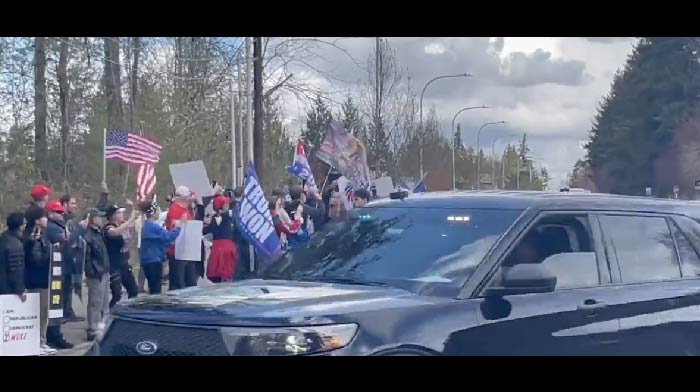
[[597, 213, 700, 355]]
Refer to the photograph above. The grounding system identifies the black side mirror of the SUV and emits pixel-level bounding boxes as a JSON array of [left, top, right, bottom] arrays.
[[485, 264, 557, 297]]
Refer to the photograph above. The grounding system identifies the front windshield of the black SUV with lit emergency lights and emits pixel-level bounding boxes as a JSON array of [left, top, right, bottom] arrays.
[[262, 207, 522, 297]]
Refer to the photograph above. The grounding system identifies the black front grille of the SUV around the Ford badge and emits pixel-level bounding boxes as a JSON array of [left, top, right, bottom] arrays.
[[99, 319, 229, 357]]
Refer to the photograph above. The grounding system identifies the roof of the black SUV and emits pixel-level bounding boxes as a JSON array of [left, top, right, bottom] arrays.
[[368, 190, 700, 219]]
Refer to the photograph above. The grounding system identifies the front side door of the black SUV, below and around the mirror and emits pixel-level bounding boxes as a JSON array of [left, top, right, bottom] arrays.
[[450, 212, 619, 355]]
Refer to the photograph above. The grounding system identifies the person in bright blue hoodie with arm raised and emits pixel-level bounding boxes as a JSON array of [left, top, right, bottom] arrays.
[[139, 200, 187, 294]]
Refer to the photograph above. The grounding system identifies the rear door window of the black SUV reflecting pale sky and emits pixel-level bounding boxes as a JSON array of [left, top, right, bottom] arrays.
[[600, 215, 681, 282]]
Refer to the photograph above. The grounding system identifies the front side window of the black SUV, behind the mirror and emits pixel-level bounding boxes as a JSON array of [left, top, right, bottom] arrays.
[[492, 214, 600, 290]]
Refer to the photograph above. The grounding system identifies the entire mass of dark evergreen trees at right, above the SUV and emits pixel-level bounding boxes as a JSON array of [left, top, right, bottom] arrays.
[[569, 37, 700, 198]]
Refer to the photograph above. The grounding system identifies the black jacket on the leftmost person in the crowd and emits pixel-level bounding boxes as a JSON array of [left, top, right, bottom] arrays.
[[0, 231, 25, 295]]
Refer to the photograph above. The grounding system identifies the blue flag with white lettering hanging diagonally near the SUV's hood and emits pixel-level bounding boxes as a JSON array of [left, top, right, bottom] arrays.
[[235, 163, 280, 257]]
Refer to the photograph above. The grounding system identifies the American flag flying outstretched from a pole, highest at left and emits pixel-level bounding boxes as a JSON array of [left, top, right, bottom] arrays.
[[105, 130, 163, 165]]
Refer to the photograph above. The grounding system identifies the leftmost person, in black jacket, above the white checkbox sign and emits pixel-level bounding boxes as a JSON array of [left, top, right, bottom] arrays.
[[0, 212, 27, 302]]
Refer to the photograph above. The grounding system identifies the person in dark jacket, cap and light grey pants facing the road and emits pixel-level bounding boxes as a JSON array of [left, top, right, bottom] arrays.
[[78, 209, 110, 341]]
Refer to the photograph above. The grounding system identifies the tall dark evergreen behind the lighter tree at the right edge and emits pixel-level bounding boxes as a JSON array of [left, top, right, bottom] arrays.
[[585, 37, 700, 195]]
